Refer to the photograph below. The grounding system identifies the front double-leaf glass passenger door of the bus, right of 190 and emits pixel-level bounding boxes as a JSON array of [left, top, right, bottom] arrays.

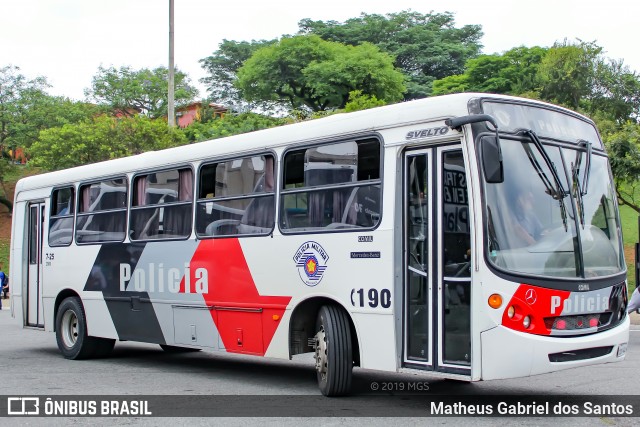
[[403, 144, 471, 376]]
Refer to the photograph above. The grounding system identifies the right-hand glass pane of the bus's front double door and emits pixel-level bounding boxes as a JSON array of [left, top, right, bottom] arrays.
[[441, 150, 471, 365]]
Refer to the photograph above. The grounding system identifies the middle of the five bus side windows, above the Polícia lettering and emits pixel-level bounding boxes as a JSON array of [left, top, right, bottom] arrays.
[[129, 168, 193, 240]]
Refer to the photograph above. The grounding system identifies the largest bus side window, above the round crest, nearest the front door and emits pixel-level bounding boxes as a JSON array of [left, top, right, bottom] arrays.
[[280, 139, 381, 232]]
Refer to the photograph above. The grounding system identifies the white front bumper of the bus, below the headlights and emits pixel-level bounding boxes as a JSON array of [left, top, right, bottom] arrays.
[[481, 316, 630, 380]]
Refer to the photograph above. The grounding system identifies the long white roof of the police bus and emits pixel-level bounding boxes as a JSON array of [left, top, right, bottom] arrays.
[[15, 93, 575, 197]]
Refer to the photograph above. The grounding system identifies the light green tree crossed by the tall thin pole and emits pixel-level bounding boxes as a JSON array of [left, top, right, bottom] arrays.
[[85, 66, 198, 118]]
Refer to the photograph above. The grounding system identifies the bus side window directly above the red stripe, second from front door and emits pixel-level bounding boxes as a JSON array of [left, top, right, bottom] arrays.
[[196, 155, 275, 237]]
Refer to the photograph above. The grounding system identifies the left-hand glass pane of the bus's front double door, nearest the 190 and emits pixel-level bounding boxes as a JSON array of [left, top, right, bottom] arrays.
[[405, 154, 431, 361]]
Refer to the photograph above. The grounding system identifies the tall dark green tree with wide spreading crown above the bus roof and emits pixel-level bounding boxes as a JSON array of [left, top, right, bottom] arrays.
[[298, 10, 482, 100]]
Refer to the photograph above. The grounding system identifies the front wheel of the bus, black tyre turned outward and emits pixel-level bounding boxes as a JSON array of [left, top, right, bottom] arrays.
[[314, 305, 353, 396]]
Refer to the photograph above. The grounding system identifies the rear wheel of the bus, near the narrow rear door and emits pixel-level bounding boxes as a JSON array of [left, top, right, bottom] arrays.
[[56, 297, 98, 360]]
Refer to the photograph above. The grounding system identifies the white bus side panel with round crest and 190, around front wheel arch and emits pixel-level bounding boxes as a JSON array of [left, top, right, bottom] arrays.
[[239, 227, 397, 371]]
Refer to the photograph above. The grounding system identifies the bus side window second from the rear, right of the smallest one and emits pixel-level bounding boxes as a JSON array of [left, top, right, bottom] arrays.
[[76, 178, 127, 243]]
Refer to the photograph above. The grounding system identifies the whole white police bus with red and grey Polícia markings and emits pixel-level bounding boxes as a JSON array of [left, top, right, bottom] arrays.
[[11, 94, 629, 395]]
